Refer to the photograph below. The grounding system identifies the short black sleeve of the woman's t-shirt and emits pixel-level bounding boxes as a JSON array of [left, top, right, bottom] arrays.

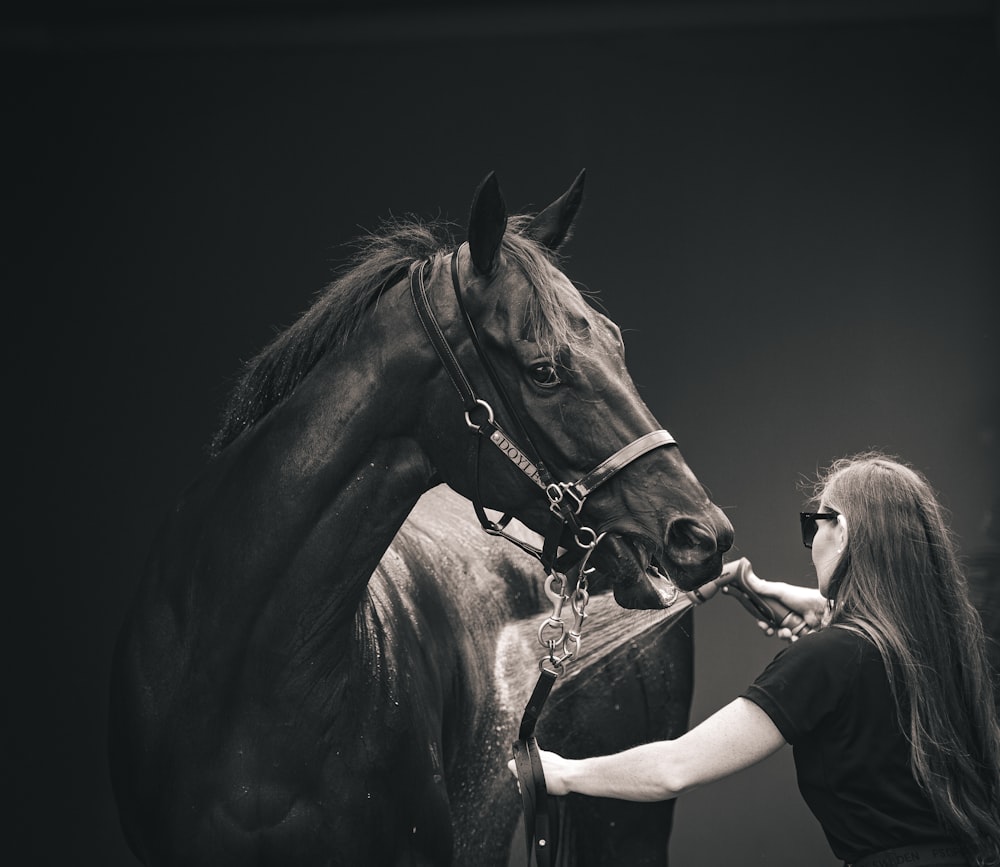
[[743, 627, 865, 745]]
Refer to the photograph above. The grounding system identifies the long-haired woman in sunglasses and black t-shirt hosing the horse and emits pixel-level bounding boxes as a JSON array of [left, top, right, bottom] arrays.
[[510, 453, 1000, 865]]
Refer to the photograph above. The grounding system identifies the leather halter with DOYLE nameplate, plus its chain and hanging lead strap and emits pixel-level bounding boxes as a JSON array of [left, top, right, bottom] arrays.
[[409, 247, 676, 867]]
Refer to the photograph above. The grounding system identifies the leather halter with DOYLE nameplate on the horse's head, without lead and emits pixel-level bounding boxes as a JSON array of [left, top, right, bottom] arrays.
[[410, 241, 676, 573]]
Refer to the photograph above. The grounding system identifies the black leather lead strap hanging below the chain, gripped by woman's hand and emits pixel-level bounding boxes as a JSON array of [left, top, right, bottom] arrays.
[[513, 668, 559, 867]]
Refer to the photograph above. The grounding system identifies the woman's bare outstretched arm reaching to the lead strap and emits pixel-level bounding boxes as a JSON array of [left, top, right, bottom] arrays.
[[508, 698, 785, 801]]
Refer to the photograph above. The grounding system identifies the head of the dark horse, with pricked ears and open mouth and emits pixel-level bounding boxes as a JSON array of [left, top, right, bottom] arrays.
[[415, 172, 733, 608]]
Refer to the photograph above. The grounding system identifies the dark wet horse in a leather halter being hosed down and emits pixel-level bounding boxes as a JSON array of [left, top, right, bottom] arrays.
[[109, 173, 733, 867]]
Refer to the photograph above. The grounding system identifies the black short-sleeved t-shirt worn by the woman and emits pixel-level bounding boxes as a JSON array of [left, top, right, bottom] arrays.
[[744, 626, 948, 862]]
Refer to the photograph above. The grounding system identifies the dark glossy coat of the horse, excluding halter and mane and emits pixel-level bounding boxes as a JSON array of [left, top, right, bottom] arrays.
[[110, 173, 731, 867]]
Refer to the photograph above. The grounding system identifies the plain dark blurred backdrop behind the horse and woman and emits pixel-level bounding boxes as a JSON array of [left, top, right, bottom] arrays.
[[0, 0, 1000, 867]]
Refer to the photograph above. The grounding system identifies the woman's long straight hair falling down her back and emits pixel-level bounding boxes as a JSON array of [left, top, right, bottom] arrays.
[[816, 452, 1000, 865]]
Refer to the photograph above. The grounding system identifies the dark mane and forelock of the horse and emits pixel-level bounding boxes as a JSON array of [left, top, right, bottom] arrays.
[[209, 216, 579, 457]]
